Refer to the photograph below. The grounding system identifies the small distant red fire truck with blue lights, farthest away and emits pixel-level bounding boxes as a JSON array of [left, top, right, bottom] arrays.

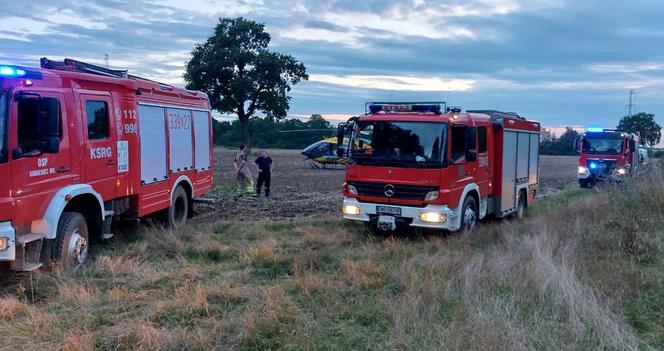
[[576, 128, 647, 188]]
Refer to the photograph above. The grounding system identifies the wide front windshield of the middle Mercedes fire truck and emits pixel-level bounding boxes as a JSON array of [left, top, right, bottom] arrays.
[[351, 121, 447, 168]]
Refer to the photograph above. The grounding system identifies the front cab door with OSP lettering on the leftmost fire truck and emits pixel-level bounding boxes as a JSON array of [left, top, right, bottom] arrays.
[[10, 90, 72, 223]]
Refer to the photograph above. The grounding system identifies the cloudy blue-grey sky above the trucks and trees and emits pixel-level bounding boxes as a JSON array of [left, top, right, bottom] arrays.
[[0, 0, 664, 132]]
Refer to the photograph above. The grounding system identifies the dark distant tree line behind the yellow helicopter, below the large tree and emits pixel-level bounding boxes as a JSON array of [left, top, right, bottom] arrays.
[[213, 114, 336, 149]]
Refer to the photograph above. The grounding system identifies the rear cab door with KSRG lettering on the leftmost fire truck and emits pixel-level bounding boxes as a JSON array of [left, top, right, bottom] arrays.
[[80, 93, 118, 199]]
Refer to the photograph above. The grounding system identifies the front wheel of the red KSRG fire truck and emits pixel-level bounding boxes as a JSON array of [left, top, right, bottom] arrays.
[[53, 212, 90, 271]]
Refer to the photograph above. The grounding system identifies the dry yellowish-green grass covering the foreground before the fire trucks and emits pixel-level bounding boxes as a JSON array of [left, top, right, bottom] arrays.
[[0, 167, 664, 350]]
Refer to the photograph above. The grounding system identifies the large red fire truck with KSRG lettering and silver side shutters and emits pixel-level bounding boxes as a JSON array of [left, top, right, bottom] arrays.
[[0, 58, 212, 271]]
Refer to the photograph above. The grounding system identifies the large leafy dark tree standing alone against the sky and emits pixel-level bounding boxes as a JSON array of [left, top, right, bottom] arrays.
[[184, 17, 309, 144]]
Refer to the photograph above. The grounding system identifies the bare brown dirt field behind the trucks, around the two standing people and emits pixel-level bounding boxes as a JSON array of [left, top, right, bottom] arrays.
[[196, 148, 577, 221]]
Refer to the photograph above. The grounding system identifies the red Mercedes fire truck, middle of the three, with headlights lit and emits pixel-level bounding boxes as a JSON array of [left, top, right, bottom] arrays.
[[338, 103, 540, 232]]
